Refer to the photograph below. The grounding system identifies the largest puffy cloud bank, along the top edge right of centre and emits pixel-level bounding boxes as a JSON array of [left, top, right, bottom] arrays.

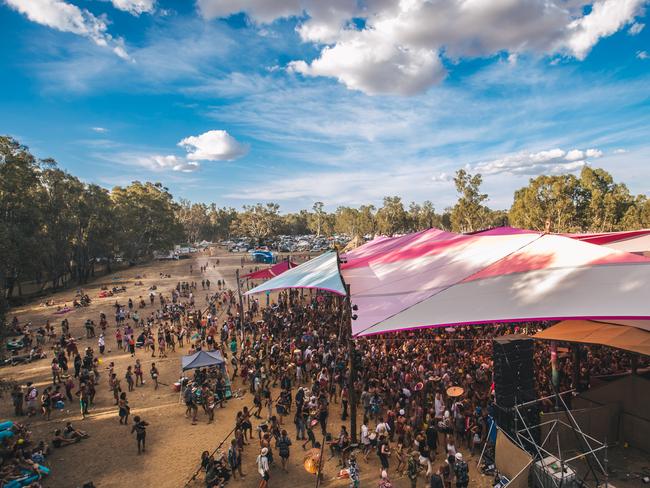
[[198, 0, 645, 95]]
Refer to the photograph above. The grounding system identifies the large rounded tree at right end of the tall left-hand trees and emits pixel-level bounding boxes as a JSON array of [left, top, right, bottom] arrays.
[[111, 181, 183, 261]]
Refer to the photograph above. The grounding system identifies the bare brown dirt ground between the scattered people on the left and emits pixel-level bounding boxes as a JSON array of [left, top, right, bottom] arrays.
[[0, 250, 491, 488]]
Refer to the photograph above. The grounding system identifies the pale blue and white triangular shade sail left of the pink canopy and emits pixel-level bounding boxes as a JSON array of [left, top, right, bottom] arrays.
[[246, 252, 345, 295]]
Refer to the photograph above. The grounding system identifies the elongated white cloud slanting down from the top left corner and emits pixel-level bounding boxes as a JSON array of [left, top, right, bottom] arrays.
[[5, 0, 129, 59]]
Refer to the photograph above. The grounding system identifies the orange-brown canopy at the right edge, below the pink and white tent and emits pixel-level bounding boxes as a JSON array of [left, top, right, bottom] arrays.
[[534, 320, 650, 356]]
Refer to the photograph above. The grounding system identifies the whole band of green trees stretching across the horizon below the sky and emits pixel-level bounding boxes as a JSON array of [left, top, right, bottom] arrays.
[[0, 132, 650, 308]]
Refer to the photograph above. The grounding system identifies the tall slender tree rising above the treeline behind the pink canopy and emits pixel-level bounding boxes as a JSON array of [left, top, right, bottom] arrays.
[[450, 169, 489, 232]]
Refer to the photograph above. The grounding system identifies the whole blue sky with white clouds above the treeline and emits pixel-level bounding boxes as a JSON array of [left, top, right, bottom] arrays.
[[0, 0, 650, 211]]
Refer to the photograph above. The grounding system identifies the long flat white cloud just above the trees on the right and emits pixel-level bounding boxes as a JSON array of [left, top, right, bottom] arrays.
[[469, 148, 603, 176]]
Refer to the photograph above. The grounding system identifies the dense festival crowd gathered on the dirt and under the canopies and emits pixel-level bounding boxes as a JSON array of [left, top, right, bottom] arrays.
[[2, 255, 644, 488]]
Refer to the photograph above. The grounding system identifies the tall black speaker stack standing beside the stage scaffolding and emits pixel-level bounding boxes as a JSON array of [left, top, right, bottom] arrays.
[[492, 335, 539, 439]]
